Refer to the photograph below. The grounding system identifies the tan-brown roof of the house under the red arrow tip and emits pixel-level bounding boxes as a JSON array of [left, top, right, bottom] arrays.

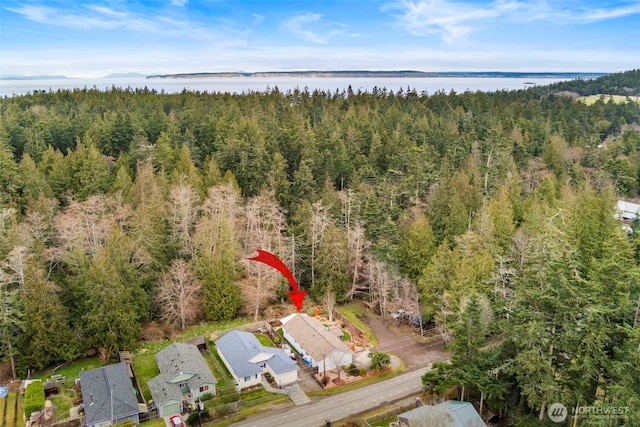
[[282, 313, 351, 360]]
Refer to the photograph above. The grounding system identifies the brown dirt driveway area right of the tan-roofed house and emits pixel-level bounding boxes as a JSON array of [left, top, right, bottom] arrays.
[[363, 316, 450, 369]]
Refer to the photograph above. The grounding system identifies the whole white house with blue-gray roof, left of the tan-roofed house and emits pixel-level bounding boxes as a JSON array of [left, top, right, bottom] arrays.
[[215, 331, 298, 391]]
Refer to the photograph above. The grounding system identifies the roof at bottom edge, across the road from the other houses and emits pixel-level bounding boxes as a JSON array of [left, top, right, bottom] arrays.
[[398, 400, 486, 427]]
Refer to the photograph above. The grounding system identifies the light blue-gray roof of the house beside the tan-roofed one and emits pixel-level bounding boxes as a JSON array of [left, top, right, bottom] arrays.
[[215, 331, 298, 377]]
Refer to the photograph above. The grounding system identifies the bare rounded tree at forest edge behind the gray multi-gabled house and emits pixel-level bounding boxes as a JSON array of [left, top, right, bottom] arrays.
[[156, 259, 202, 330]]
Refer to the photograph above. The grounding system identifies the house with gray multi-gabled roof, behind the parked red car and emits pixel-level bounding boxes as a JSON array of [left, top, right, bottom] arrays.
[[148, 343, 218, 417]]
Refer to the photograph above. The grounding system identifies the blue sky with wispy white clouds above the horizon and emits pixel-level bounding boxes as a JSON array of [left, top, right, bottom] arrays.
[[0, 0, 640, 78]]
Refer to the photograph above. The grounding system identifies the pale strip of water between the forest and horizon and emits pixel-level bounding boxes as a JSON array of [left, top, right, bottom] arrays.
[[0, 77, 567, 97]]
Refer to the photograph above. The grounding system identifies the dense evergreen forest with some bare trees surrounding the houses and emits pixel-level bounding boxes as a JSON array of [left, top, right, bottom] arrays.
[[0, 70, 640, 426]]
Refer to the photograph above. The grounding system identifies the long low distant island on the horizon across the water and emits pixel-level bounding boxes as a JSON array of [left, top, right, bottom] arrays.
[[147, 70, 608, 79]]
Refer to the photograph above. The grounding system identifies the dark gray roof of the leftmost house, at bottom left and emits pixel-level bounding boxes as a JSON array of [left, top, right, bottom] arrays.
[[80, 362, 138, 425]]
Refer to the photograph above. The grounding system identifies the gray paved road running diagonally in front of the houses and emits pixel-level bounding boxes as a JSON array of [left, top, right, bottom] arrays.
[[232, 367, 430, 427]]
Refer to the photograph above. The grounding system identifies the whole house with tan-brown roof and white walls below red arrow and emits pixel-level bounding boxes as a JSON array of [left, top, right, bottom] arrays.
[[282, 313, 353, 370]]
